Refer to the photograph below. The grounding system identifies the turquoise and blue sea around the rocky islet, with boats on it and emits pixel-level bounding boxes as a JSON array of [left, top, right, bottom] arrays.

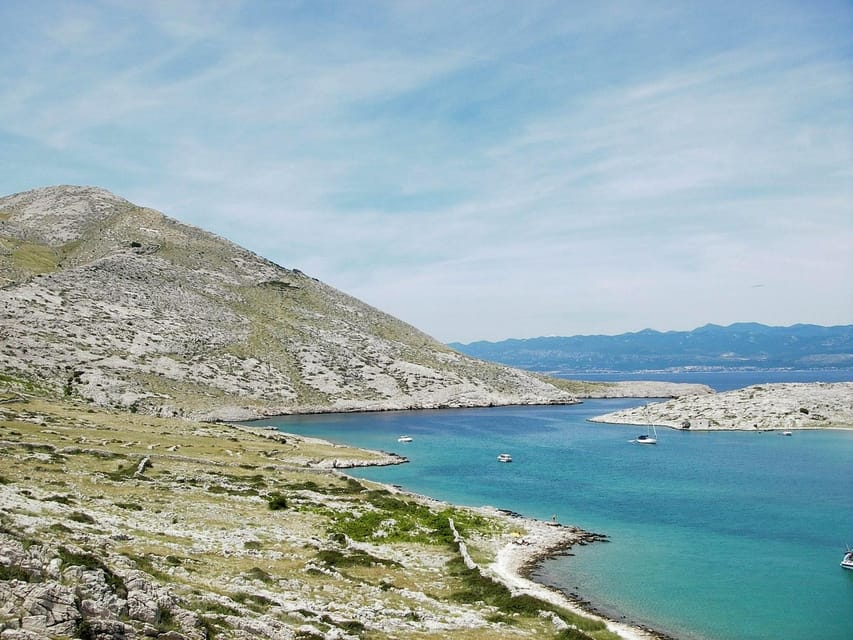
[[250, 370, 853, 640]]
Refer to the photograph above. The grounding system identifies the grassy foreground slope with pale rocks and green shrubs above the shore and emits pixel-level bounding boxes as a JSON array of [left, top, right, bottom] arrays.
[[0, 396, 624, 640]]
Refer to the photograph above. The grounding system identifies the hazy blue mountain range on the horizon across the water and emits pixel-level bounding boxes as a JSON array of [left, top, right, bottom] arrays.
[[449, 322, 853, 374]]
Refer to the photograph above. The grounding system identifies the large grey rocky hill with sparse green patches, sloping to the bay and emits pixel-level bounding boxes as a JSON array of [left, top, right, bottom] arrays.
[[0, 186, 584, 419]]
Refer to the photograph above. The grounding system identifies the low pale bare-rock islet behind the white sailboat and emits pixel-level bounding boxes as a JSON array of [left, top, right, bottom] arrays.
[[591, 382, 853, 431]]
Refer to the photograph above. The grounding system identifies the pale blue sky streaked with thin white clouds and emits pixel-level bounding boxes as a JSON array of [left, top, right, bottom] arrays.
[[0, 0, 853, 342]]
